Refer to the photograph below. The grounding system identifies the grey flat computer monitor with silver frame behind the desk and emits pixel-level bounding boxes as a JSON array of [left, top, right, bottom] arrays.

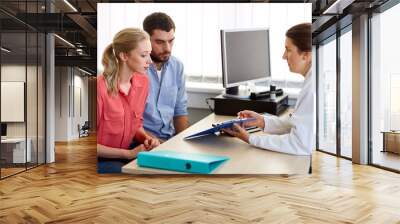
[[221, 28, 271, 95]]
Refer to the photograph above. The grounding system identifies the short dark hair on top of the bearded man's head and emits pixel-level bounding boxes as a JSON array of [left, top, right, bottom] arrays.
[[143, 12, 175, 36]]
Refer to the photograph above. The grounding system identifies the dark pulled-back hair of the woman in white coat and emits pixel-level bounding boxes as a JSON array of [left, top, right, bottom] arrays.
[[286, 23, 312, 52]]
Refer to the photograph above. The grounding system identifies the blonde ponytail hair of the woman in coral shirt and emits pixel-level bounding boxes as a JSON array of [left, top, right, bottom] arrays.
[[102, 28, 150, 93]]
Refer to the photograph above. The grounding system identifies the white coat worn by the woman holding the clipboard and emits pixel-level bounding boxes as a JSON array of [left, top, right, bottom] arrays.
[[249, 69, 315, 155]]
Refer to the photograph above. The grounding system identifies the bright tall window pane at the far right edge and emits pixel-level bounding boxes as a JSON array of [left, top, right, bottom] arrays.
[[370, 1, 400, 170]]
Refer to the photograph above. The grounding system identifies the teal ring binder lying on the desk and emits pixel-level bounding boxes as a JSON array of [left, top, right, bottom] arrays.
[[137, 150, 229, 174]]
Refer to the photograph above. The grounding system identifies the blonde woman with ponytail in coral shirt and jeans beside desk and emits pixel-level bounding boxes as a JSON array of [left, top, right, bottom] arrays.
[[97, 28, 160, 173]]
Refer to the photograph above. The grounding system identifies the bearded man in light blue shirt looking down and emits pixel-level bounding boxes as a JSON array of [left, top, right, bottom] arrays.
[[143, 12, 189, 142]]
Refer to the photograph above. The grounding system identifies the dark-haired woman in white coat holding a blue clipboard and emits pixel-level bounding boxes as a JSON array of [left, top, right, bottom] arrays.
[[225, 23, 315, 155]]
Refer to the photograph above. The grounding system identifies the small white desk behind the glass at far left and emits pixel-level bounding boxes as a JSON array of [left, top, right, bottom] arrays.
[[1, 138, 32, 163]]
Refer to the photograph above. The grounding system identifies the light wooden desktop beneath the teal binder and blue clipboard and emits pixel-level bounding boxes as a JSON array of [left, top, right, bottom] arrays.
[[122, 114, 311, 175]]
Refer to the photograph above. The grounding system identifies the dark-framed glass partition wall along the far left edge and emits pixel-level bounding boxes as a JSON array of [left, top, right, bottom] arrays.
[[0, 1, 46, 179]]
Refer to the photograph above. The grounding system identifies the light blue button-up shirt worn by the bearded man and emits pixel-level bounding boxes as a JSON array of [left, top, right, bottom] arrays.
[[143, 56, 187, 139]]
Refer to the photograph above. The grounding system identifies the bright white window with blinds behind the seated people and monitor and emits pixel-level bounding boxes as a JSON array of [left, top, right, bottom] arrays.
[[97, 3, 311, 83]]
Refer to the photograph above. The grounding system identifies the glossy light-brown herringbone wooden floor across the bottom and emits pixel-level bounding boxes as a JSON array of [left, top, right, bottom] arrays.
[[0, 134, 400, 223]]
